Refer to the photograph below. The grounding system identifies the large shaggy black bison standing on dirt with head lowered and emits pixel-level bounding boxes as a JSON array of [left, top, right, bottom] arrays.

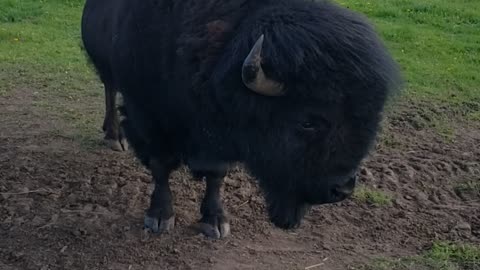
[[82, 0, 400, 237]]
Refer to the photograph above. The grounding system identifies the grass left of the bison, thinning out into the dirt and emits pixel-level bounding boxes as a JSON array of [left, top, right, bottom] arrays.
[[0, 0, 103, 146]]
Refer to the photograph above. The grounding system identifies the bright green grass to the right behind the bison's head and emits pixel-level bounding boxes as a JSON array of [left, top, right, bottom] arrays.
[[339, 0, 480, 108]]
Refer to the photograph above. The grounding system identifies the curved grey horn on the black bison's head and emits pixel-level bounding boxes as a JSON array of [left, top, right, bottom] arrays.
[[242, 35, 284, 96]]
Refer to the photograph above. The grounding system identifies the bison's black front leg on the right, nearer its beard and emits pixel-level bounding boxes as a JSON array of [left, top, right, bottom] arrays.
[[195, 172, 230, 238]]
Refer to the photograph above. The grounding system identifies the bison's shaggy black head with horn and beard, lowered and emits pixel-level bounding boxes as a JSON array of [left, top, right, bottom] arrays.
[[210, 4, 399, 228]]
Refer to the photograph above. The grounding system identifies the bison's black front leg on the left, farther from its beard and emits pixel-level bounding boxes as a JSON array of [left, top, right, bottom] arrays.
[[144, 158, 176, 233]]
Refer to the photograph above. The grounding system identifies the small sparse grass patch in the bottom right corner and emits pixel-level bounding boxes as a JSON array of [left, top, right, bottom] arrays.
[[357, 242, 480, 270]]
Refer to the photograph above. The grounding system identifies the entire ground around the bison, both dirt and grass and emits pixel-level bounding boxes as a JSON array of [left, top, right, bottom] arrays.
[[0, 0, 480, 270]]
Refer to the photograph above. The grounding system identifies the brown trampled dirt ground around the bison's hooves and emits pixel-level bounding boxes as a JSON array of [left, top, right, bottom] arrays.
[[0, 89, 480, 270]]
